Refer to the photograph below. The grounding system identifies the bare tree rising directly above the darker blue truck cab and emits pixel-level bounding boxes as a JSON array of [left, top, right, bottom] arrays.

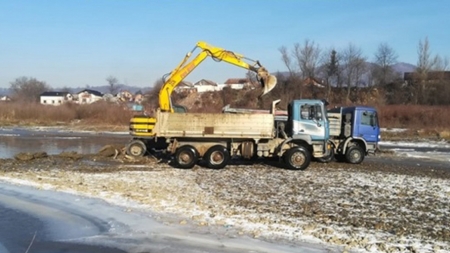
[[342, 43, 366, 101]]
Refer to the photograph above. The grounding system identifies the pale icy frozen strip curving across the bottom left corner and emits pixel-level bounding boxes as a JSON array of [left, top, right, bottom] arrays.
[[0, 182, 329, 253]]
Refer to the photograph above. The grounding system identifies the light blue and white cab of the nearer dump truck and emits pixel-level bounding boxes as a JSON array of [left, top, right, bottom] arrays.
[[292, 103, 328, 141]]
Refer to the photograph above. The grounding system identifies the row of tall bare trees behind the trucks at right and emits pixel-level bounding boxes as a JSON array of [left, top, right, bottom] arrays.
[[279, 38, 450, 104]]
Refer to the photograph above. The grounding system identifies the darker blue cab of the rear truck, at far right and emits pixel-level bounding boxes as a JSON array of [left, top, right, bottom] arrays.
[[354, 109, 380, 142]]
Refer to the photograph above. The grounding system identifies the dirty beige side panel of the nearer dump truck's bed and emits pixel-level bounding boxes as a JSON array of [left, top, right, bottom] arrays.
[[153, 112, 274, 139]]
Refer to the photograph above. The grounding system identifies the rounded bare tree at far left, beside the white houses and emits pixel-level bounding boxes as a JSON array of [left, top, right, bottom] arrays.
[[10, 76, 51, 102]]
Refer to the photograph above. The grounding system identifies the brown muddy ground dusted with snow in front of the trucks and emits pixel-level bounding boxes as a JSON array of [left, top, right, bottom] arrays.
[[0, 147, 450, 252]]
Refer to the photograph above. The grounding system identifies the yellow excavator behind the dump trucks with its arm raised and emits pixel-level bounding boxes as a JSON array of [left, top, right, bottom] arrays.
[[130, 41, 277, 138]]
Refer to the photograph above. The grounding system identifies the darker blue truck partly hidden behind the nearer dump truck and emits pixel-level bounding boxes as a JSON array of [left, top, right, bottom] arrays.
[[318, 106, 380, 164]]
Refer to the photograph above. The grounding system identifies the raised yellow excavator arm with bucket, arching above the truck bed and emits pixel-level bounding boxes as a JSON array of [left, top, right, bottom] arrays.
[[159, 41, 277, 112]]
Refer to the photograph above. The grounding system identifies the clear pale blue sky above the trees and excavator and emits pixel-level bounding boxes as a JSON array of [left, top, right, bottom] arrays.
[[0, 0, 450, 88]]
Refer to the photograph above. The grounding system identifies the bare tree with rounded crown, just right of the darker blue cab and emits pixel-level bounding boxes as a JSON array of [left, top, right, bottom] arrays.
[[372, 43, 398, 85]]
